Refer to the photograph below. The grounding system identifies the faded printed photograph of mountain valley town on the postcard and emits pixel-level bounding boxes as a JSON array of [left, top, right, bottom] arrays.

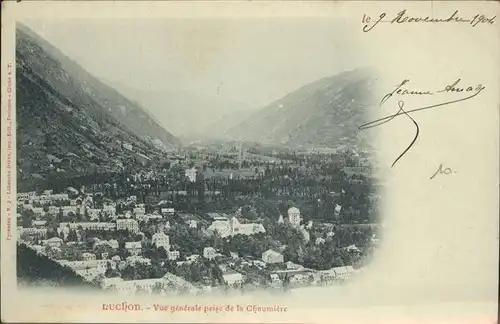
[[16, 19, 381, 294]]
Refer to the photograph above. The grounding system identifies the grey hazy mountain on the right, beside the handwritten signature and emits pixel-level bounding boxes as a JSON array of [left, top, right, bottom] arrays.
[[225, 69, 375, 148]]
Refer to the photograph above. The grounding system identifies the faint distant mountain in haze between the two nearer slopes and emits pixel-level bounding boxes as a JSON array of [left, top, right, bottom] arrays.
[[106, 81, 251, 139]]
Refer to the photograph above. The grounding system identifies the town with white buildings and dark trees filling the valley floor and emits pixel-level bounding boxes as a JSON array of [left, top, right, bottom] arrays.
[[17, 143, 380, 293]]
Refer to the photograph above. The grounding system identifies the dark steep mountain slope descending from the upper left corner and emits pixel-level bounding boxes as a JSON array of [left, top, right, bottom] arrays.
[[16, 24, 180, 190]]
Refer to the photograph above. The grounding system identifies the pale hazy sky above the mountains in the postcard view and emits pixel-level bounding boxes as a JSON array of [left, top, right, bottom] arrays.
[[23, 18, 366, 107]]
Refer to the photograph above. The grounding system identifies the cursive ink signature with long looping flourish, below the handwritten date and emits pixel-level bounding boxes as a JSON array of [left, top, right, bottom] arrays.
[[358, 79, 486, 167]]
